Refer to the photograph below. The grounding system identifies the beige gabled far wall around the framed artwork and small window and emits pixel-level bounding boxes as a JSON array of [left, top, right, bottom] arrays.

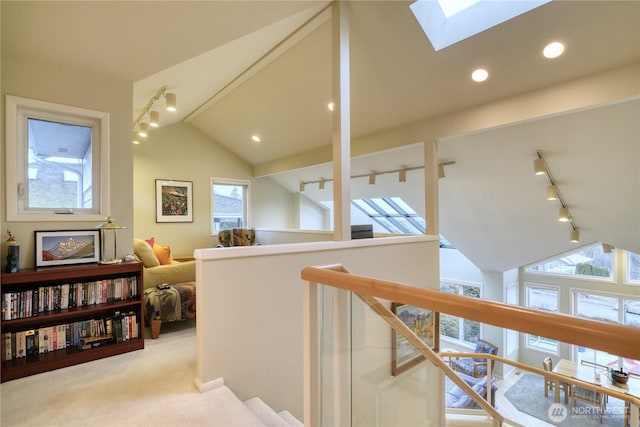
[[133, 123, 292, 256]]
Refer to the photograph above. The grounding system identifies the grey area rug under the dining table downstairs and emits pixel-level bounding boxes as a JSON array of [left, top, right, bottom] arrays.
[[504, 374, 624, 427]]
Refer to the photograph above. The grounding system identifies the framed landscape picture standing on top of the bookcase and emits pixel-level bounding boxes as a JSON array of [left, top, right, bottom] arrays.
[[35, 229, 100, 267]]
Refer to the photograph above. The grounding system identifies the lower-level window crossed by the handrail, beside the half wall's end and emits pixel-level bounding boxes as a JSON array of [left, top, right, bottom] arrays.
[[440, 280, 481, 344]]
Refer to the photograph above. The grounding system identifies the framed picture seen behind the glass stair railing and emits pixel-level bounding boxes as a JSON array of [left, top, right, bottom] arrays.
[[391, 302, 440, 376]]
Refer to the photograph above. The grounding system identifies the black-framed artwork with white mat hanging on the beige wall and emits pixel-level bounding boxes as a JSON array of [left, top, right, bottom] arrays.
[[156, 179, 193, 222]]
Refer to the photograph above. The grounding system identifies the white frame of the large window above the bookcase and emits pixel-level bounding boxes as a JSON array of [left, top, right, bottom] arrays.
[[5, 95, 110, 222]]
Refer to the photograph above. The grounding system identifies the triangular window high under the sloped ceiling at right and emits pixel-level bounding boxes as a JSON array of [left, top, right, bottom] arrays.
[[527, 244, 614, 281]]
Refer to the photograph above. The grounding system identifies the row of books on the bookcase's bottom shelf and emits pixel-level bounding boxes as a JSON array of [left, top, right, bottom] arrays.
[[1, 312, 141, 361]]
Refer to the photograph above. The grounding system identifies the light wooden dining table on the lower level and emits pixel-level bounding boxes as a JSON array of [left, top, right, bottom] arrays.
[[553, 359, 640, 427]]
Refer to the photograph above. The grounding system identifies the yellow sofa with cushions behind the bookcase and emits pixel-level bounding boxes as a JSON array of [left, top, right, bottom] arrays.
[[133, 238, 196, 289]]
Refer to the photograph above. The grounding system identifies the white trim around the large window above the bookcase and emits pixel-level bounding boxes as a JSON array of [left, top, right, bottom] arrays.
[[5, 95, 110, 222]]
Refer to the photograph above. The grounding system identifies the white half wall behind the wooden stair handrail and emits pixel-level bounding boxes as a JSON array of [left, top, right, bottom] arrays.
[[195, 236, 439, 419]]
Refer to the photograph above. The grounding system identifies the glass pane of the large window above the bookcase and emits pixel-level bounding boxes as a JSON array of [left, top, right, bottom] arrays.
[[26, 118, 92, 209]]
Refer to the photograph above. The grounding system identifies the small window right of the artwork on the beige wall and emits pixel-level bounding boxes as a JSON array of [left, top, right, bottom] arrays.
[[211, 178, 249, 234]]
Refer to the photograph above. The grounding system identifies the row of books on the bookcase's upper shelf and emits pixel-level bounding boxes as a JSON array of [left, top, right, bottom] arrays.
[[2, 276, 139, 320]]
